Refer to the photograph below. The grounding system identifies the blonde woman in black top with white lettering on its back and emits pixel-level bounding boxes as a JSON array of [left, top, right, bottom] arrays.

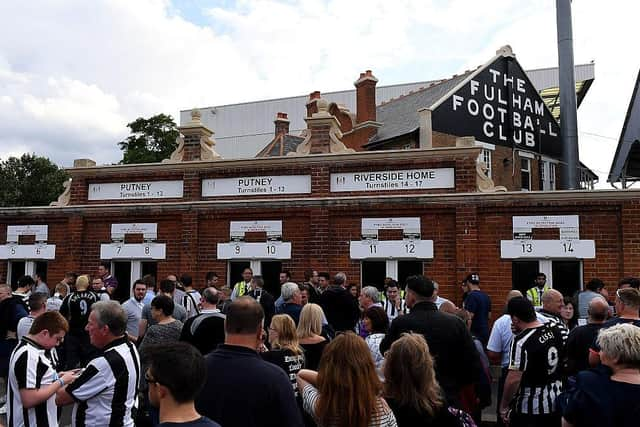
[[261, 314, 304, 396]]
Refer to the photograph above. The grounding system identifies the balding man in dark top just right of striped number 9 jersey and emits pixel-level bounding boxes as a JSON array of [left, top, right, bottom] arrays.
[[567, 297, 609, 375]]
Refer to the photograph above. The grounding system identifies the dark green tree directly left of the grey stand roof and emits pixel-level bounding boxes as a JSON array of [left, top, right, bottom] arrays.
[[118, 114, 180, 164]]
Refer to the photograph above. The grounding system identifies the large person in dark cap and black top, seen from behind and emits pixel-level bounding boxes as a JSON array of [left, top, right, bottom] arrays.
[[380, 275, 480, 408]]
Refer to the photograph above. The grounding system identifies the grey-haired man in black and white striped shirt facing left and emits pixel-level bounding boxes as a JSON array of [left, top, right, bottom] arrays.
[[56, 301, 141, 427]]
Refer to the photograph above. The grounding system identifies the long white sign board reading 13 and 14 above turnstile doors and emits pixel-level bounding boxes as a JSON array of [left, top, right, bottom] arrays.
[[500, 239, 596, 259]]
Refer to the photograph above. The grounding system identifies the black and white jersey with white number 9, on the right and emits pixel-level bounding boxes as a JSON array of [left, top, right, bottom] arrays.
[[509, 323, 564, 415]]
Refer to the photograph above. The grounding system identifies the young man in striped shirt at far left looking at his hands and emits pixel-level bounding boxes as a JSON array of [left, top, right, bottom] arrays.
[[7, 311, 76, 427]]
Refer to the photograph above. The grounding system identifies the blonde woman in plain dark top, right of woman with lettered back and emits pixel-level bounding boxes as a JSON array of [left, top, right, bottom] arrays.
[[298, 303, 329, 371]]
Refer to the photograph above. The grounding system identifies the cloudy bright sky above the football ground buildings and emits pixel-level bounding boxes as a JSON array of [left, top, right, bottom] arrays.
[[0, 0, 640, 187]]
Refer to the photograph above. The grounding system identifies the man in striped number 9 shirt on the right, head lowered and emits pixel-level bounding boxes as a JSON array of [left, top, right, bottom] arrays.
[[500, 297, 563, 427]]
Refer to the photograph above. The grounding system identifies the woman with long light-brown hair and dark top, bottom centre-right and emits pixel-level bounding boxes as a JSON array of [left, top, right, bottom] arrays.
[[384, 333, 468, 427]]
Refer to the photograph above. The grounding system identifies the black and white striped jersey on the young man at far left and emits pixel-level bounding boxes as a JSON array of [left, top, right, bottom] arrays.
[[7, 337, 58, 427]]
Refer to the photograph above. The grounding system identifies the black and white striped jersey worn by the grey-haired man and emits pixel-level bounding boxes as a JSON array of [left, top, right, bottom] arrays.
[[67, 337, 141, 427]]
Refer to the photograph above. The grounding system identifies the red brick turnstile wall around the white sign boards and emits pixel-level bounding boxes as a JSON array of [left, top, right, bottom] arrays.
[[0, 155, 640, 330]]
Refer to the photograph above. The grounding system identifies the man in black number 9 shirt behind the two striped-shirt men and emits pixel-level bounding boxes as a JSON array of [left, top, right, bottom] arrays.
[[60, 275, 100, 370]]
